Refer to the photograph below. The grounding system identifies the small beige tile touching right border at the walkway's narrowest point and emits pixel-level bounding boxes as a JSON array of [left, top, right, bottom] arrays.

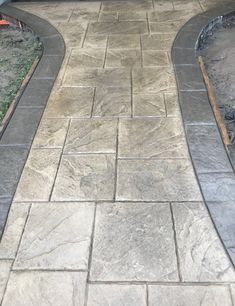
[[143, 50, 170, 67]]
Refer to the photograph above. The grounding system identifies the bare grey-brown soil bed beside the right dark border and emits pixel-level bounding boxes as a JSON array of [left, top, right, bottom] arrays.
[[198, 16, 235, 143]]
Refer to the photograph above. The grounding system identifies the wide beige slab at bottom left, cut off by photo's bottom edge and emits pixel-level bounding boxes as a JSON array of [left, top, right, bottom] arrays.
[[2, 271, 86, 306]]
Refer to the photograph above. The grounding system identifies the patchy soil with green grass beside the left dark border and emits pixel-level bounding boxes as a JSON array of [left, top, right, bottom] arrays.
[[0, 20, 42, 123]]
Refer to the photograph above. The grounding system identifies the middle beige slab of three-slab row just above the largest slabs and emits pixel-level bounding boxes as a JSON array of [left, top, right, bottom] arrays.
[[52, 154, 115, 201]]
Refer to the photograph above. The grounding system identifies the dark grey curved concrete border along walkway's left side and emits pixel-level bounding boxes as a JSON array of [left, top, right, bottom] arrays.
[[0, 5, 65, 236]]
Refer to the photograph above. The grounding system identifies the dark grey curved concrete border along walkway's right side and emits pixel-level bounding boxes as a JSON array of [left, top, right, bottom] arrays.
[[172, 3, 235, 264]]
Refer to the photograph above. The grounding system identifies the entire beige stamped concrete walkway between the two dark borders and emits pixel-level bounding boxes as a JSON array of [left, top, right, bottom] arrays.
[[0, 0, 235, 306]]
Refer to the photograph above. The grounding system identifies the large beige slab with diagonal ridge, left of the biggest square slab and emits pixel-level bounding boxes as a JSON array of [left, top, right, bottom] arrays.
[[14, 202, 94, 270]]
